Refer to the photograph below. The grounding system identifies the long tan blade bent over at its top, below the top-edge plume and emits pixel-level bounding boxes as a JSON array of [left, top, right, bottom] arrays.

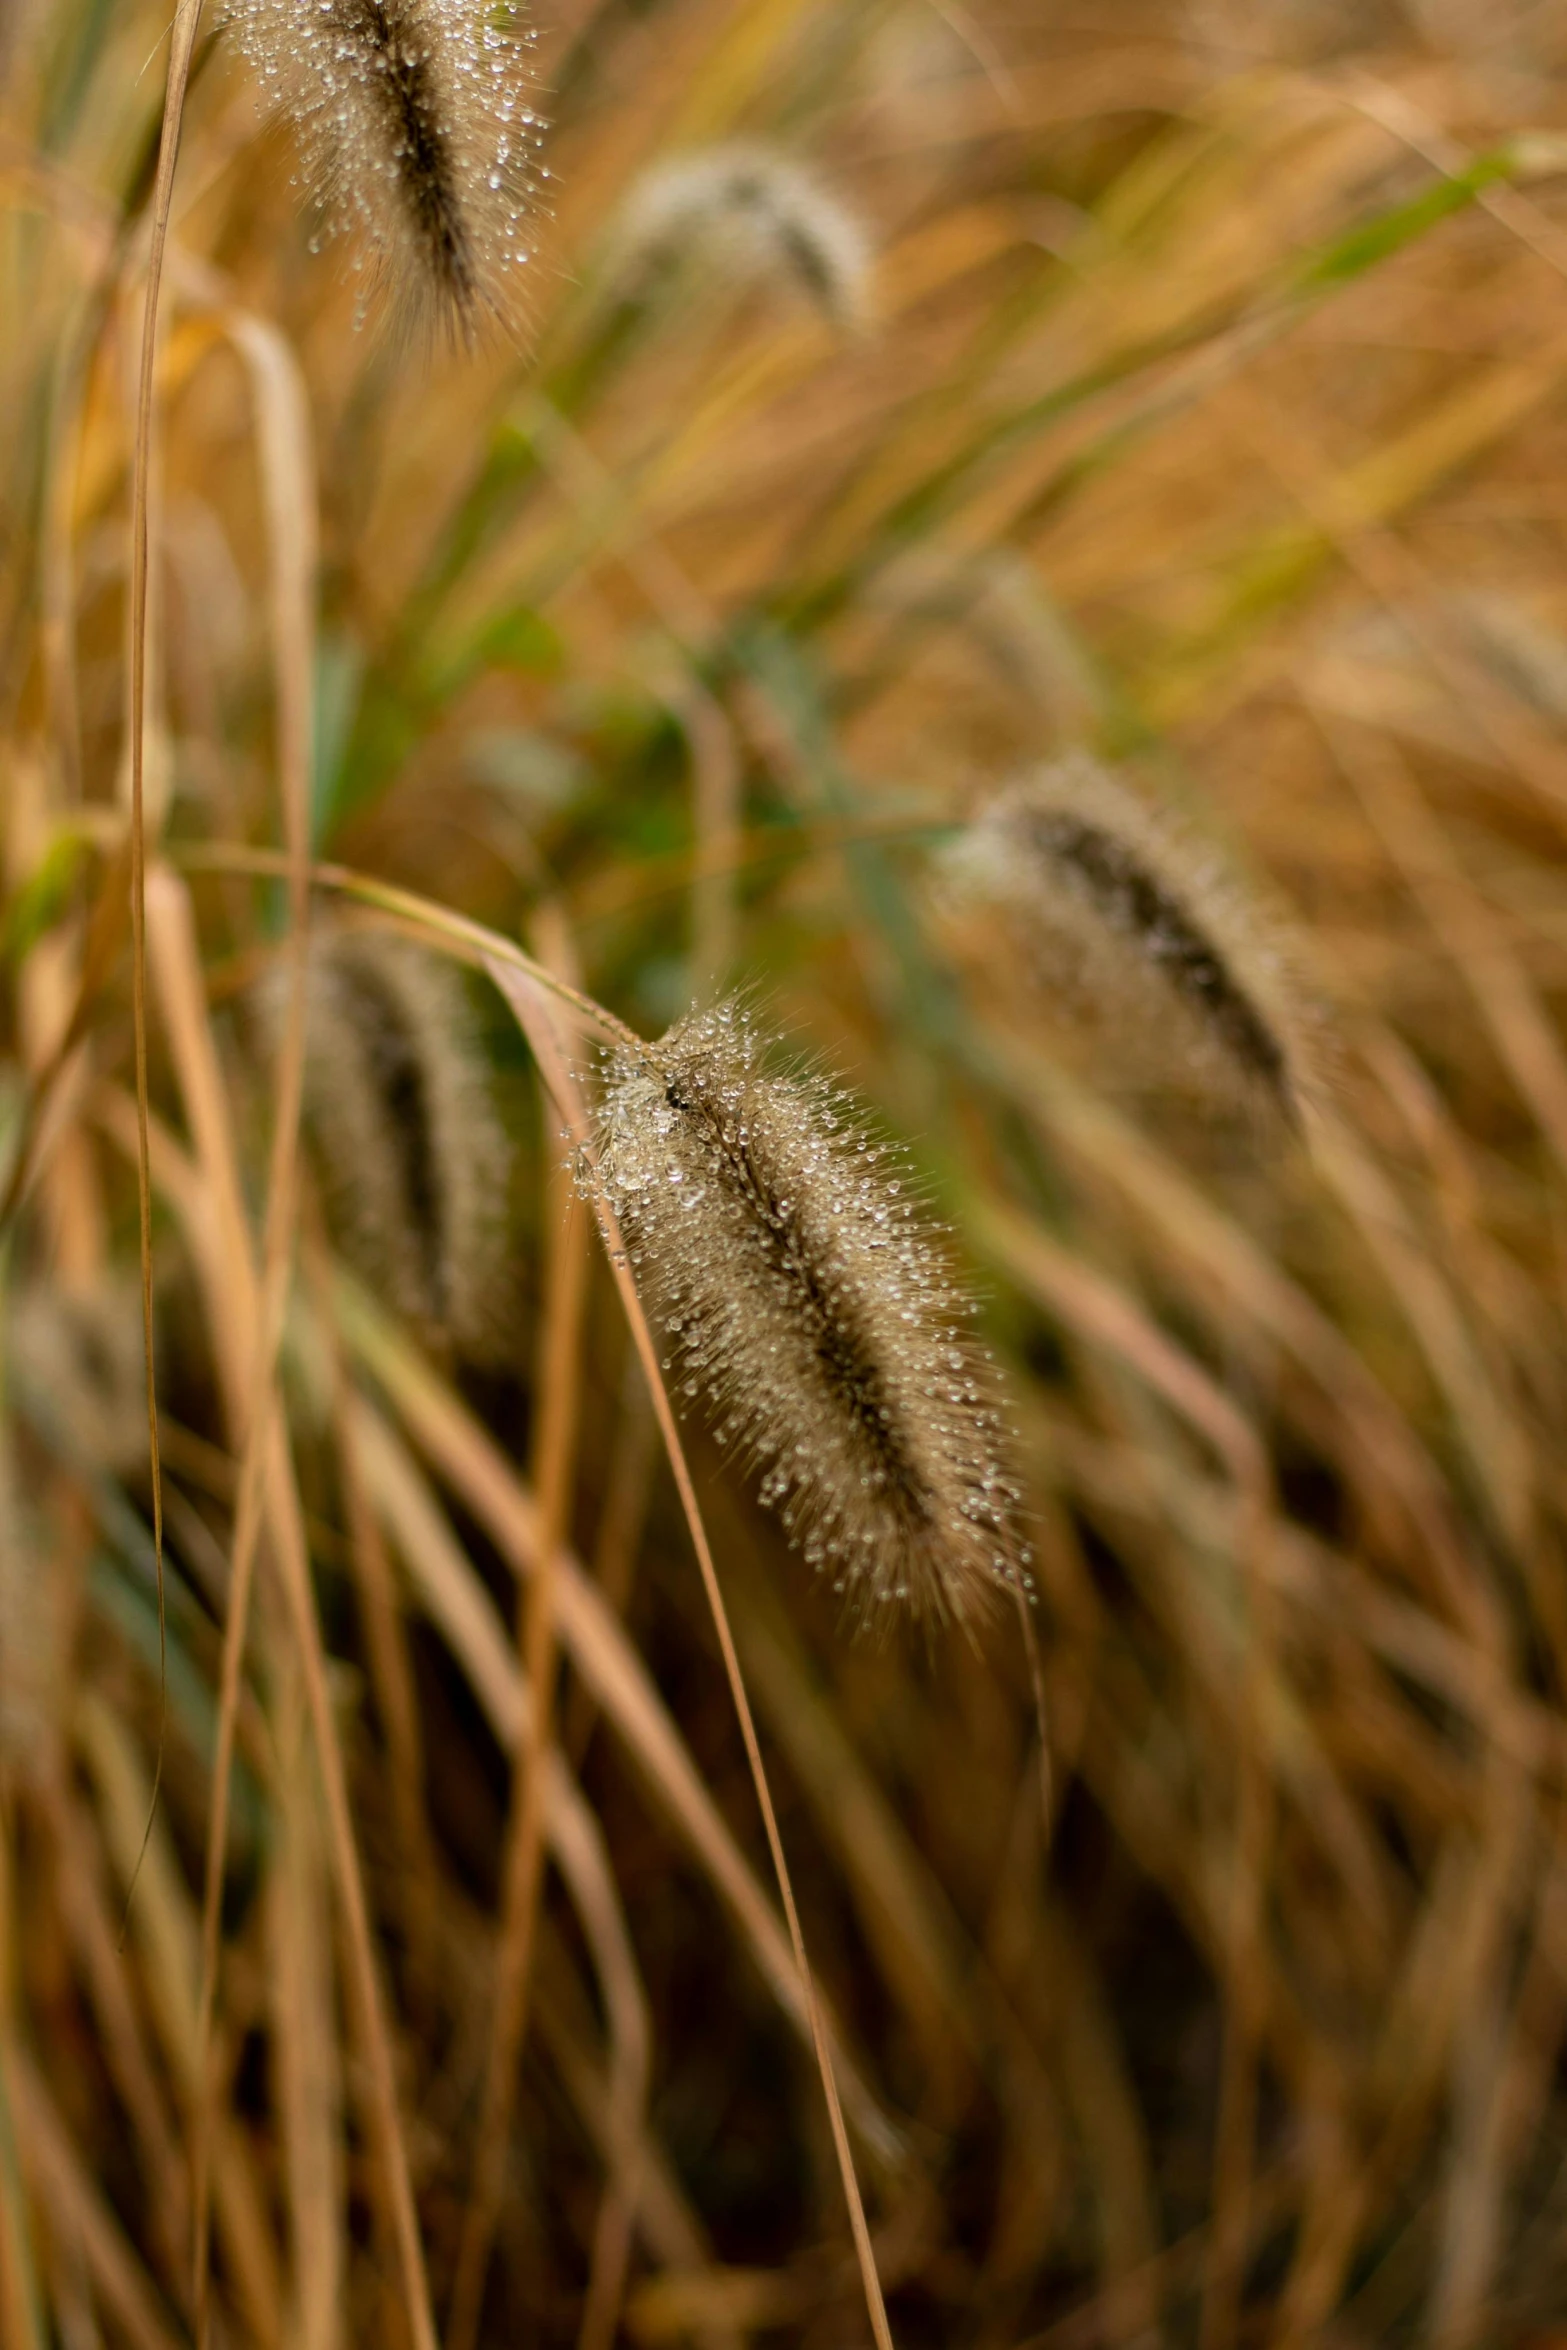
[[193, 313, 317, 2343]]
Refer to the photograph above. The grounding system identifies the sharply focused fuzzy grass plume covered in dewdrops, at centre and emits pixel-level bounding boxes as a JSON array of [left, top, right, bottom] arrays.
[[599, 1001, 1024, 1619]]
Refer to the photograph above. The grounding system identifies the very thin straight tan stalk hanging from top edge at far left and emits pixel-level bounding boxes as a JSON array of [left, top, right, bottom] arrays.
[[119, 0, 202, 1936]]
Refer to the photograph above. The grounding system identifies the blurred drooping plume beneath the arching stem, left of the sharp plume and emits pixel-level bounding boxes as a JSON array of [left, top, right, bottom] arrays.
[[265, 933, 510, 1358]]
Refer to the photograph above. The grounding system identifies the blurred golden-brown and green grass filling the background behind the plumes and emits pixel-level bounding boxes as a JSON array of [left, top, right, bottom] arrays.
[[0, 0, 1567, 2350]]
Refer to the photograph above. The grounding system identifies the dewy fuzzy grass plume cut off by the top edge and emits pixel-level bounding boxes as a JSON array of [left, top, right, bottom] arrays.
[[228, 0, 545, 334]]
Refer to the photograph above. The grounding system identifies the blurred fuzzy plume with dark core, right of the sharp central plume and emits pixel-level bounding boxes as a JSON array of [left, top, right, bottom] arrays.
[[944, 752, 1313, 1128]]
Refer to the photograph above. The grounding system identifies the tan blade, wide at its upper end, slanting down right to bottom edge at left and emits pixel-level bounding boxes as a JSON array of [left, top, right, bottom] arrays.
[[150, 872, 435, 2350]]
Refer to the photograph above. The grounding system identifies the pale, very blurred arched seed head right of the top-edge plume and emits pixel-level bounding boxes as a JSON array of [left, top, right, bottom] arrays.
[[611, 146, 872, 331]]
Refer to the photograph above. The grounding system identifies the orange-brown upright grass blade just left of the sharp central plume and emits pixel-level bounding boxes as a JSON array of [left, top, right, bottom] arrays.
[[446, 1107, 594, 2350]]
